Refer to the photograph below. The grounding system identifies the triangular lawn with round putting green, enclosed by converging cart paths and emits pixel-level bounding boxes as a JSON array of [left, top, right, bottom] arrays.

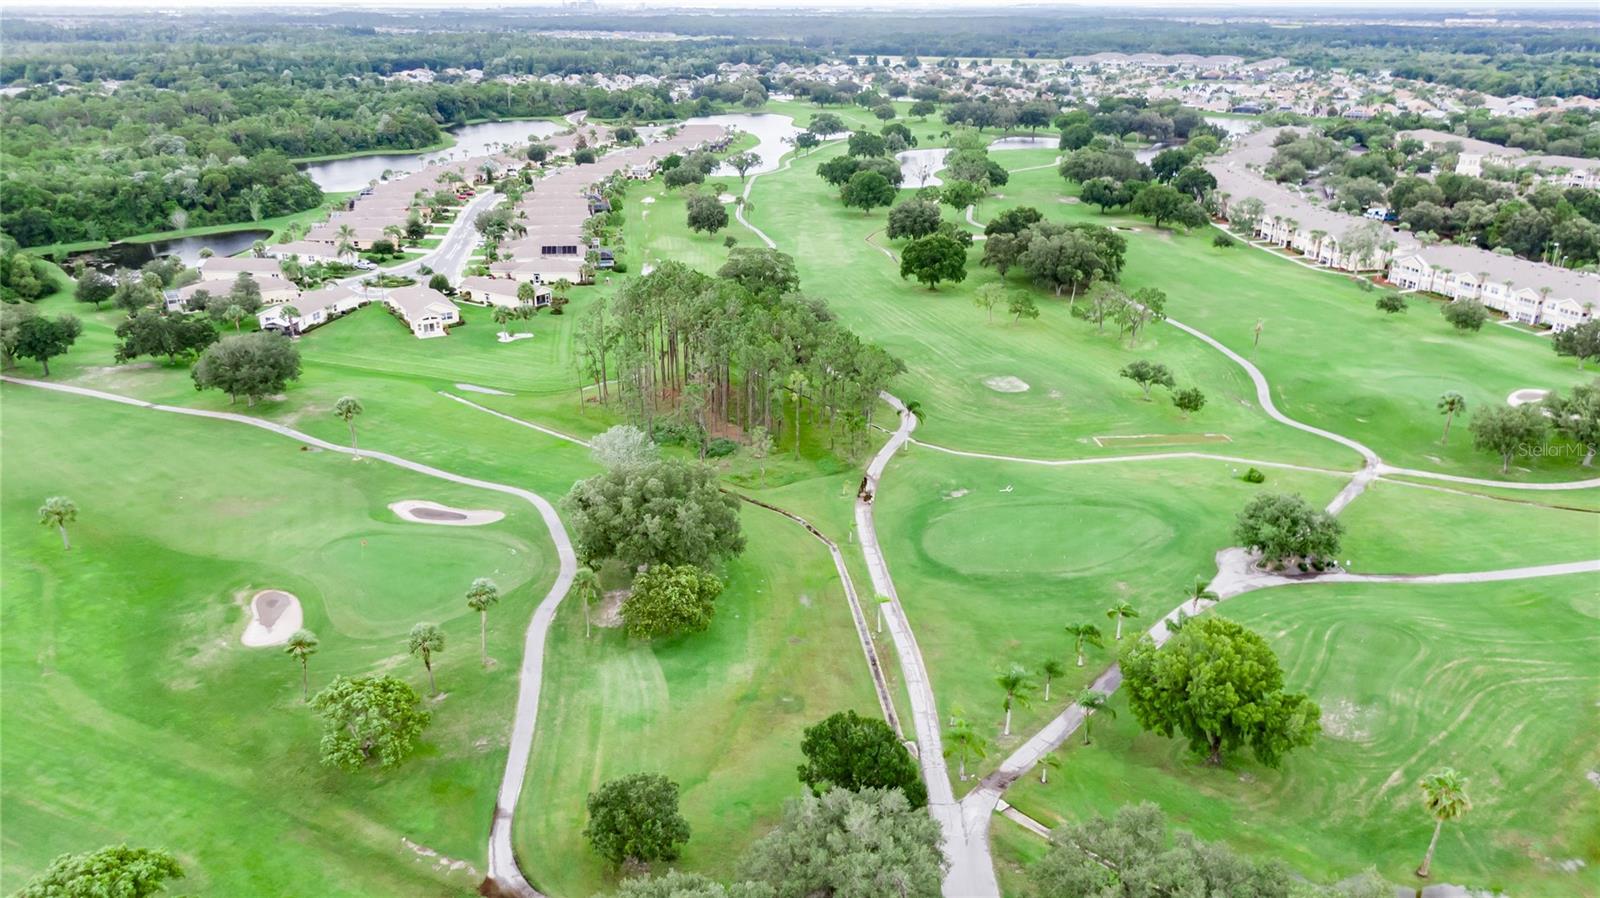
[[875, 448, 1344, 781]]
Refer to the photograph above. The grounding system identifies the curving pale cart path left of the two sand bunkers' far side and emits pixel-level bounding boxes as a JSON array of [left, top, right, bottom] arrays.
[[0, 376, 578, 898]]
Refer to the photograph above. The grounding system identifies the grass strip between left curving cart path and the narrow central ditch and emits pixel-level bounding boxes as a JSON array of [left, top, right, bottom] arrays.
[[517, 506, 877, 895]]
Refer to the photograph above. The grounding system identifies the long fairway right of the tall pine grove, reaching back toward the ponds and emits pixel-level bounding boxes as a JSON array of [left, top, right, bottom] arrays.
[[732, 138, 1358, 466]]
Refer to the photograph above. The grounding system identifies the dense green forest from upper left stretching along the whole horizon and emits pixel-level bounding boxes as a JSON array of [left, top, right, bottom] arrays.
[[0, 10, 1600, 247]]
